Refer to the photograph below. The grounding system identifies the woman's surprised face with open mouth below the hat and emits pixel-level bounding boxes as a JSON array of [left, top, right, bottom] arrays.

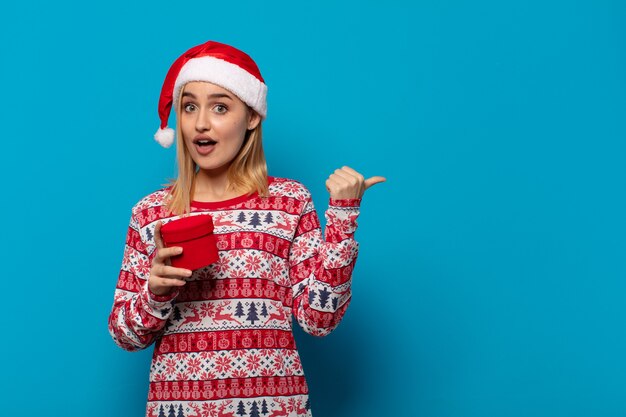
[[179, 81, 260, 172]]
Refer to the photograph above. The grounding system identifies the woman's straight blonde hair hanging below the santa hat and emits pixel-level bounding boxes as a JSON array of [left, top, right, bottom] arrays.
[[164, 84, 269, 215]]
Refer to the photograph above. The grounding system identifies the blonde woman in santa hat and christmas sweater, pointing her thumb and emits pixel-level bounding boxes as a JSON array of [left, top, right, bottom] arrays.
[[109, 41, 385, 417]]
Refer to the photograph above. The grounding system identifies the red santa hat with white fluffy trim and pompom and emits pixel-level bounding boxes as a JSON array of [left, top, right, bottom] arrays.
[[154, 41, 267, 148]]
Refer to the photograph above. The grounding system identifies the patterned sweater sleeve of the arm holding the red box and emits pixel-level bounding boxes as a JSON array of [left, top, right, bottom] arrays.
[[108, 213, 177, 351]]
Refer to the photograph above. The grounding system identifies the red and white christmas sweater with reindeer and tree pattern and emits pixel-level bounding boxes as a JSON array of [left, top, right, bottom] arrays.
[[109, 177, 361, 417]]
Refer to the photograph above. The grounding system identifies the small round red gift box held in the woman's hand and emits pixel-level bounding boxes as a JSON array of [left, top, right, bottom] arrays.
[[161, 214, 219, 270]]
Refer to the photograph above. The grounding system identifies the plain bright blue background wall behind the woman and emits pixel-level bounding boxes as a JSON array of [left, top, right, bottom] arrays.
[[0, 0, 626, 417]]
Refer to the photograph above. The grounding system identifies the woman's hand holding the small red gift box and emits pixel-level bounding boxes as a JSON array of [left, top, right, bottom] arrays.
[[148, 221, 192, 295]]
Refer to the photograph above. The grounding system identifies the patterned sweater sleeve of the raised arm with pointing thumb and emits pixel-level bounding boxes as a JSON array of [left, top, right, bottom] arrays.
[[289, 196, 361, 336]]
